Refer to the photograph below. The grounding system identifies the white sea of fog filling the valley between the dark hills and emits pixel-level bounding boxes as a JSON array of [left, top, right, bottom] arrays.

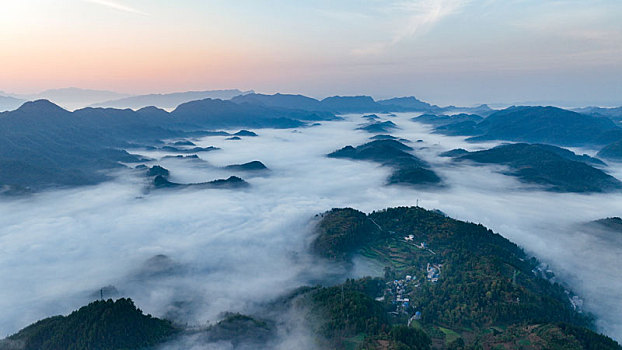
[[0, 114, 622, 341]]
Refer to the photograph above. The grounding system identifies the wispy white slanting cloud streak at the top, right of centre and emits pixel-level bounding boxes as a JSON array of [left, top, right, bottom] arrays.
[[353, 0, 470, 55]]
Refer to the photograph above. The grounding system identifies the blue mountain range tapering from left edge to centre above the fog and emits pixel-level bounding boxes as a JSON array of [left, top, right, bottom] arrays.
[[0, 99, 336, 192]]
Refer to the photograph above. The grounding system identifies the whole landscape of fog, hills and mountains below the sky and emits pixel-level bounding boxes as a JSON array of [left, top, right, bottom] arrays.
[[0, 90, 622, 350]]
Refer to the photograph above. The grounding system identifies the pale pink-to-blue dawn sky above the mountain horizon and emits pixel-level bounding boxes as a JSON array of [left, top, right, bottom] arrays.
[[0, 0, 622, 105]]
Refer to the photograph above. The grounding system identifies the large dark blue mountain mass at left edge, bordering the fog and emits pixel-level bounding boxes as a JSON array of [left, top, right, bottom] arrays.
[[0, 100, 161, 193]]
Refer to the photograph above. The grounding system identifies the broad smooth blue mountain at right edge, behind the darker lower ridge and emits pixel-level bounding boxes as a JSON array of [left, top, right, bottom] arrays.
[[472, 107, 622, 146]]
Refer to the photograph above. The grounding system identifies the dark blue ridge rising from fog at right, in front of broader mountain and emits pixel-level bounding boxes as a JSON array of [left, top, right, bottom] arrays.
[[453, 143, 622, 192]]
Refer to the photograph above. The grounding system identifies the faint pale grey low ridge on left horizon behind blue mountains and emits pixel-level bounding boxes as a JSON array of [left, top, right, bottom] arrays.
[[92, 89, 252, 109]]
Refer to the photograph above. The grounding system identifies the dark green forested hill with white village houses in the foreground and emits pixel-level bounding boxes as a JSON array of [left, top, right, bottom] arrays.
[[310, 207, 621, 349]]
